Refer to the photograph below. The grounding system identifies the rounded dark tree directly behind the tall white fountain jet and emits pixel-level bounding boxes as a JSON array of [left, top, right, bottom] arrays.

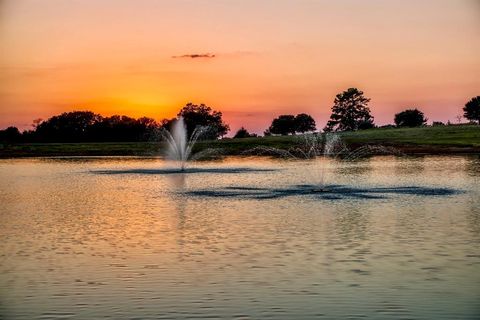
[[177, 103, 230, 139]]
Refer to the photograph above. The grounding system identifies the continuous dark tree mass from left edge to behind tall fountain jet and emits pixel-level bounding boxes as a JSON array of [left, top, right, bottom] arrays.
[[5, 103, 228, 142]]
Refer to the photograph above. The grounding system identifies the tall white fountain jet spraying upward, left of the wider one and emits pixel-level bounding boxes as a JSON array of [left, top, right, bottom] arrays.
[[164, 117, 204, 171]]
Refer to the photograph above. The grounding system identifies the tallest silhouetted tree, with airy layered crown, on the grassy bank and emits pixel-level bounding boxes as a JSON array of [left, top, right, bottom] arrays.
[[324, 88, 373, 132]]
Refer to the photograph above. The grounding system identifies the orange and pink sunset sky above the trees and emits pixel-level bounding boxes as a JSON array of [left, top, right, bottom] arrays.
[[0, 0, 480, 133]]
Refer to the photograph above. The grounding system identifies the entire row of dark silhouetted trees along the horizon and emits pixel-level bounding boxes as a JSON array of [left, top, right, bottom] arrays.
[[0, 88, 480, 143]]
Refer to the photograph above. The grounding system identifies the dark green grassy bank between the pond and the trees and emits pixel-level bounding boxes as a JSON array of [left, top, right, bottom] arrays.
[[0, 125, 480, 158]]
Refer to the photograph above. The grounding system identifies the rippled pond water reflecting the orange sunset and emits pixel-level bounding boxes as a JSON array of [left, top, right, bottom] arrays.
[[0, 156, 480, 319]]
